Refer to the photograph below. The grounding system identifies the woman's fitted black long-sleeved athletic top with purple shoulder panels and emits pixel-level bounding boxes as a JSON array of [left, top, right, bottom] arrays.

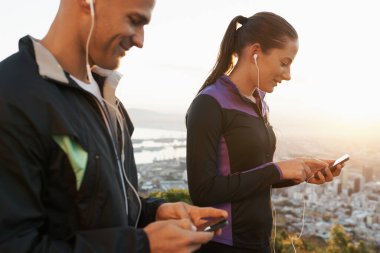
[[186, 75, 294, 250]]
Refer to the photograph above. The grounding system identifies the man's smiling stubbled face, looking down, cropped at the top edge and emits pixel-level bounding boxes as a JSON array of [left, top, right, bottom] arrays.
[[89, 0, 154, 69]]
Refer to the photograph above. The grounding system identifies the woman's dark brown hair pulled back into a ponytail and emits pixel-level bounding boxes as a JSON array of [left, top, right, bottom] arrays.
[[199, 12, 298, 92]]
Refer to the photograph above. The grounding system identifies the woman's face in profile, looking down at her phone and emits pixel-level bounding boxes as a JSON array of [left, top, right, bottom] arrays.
[[257, 40, 298, 93]]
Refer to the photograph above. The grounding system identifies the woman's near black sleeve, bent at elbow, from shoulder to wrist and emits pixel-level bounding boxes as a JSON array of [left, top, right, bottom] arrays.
[[186, 95, 280, 206]]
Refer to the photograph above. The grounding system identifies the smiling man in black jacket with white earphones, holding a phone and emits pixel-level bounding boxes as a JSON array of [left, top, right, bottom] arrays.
[[0, 0, 227, 253]]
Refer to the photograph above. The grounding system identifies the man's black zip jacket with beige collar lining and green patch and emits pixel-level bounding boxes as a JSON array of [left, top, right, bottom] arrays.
[[0, 37, 162, 253]]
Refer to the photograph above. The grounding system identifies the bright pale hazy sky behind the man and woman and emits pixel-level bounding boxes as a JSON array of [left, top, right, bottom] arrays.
[[0, 0, 380, 140]]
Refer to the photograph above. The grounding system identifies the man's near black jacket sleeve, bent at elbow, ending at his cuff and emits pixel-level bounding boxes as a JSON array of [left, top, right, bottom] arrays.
[[0, 102, 149, 253]]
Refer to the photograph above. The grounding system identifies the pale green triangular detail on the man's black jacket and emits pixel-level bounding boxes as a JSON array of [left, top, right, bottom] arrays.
[[53, 135, 88, 190]]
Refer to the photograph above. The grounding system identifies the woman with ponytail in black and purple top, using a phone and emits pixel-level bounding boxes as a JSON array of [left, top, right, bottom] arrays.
[[186, 12, 342, 253]]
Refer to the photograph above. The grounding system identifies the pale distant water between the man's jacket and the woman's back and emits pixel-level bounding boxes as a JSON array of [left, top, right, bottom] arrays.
[[132, 128, 186, 164]]
